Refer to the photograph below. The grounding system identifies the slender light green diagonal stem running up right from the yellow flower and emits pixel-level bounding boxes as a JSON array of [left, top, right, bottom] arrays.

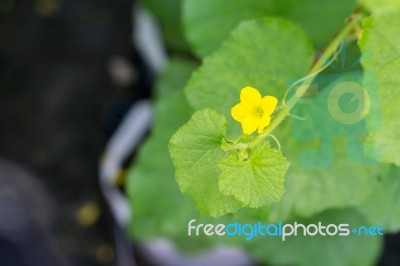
[[252, 11, 363, 145]]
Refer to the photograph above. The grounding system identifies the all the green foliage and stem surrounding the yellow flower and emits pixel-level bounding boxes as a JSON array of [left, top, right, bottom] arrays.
[[128, 0, 400, 265]]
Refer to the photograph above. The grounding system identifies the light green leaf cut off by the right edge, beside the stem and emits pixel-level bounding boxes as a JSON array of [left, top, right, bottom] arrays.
[[359, 11, 400, 165]]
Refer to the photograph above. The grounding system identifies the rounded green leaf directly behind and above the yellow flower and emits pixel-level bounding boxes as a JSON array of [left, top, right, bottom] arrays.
[[185, 18, 314, 133]]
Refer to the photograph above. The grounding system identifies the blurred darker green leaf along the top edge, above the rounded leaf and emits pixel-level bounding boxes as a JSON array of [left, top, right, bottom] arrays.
[[183, 0, 356, 56]]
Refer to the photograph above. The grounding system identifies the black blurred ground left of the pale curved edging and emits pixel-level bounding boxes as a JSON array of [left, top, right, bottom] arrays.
[[0, 0, 149, 266]]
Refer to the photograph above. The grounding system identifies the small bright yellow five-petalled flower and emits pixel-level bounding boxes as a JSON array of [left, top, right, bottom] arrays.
[[231, 86, 278, 135]]
